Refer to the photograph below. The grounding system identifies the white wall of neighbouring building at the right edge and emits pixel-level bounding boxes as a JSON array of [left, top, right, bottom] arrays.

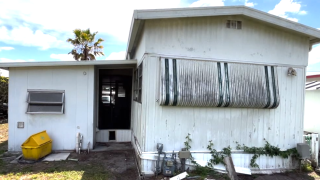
[[304, 90, 320, 134]]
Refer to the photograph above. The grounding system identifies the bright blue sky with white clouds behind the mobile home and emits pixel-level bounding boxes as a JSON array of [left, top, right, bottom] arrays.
[[0, 0, 320, 75]]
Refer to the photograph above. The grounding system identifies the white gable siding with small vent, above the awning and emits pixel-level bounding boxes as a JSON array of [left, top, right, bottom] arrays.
[[144, 16, 309, 66]]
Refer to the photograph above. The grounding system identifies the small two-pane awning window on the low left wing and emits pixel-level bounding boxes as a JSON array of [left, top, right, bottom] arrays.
[[27, 90, 64, 114]]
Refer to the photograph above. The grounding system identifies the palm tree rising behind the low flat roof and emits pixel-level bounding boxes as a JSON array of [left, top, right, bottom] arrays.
[[67, 29, 104, 61]]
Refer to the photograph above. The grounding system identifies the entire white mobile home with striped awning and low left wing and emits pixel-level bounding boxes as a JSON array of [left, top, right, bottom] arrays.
[[1, 6, 320, 174]]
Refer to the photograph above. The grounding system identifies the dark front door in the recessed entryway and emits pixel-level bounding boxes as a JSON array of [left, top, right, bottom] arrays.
[[99, 74, 132, 129]]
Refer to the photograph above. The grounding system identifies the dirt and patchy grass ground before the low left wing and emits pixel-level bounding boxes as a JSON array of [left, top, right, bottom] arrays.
[[0, 120, 138, 180]]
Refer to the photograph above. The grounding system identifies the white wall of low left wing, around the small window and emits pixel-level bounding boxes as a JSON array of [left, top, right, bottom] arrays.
[[8, 66, 94, 151]]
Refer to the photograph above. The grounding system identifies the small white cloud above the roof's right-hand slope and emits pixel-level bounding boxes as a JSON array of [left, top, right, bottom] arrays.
[[269, 0, 307, 22]]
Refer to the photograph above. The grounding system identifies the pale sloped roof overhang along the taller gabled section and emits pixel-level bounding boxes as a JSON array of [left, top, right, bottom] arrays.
[[126, 6, 320, 59]]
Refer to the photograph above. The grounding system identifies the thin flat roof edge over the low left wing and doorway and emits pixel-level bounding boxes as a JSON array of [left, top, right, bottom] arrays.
[[0, 60, 137, 70]]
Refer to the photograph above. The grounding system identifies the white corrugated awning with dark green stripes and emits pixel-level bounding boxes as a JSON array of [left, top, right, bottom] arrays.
[[159, 59, 280, 109]]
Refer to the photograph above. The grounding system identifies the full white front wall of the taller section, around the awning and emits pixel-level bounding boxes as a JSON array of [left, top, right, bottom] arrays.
[[132, 16, 309, 174]]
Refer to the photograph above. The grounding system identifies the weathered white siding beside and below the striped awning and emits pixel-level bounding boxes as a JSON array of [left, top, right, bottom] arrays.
[[141, 57, 305, 171]]
